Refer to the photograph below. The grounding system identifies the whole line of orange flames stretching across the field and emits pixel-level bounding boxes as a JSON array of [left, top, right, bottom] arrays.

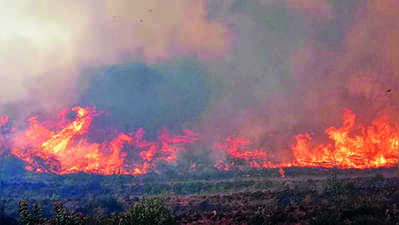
[[0, 107, 399, 177]]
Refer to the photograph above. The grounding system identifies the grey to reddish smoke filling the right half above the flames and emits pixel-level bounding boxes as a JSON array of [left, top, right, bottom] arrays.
[[201, 0, 399, 153]]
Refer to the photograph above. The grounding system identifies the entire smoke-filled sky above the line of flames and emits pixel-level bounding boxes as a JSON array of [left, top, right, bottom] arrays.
[[0, 0, 399, 149]]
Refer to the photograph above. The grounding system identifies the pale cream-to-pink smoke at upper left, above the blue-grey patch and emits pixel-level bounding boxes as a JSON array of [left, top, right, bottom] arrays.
[[0, 0, 230, 116]]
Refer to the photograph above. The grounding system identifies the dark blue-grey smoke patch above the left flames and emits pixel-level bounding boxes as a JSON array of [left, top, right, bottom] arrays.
[[79, 60, 211, 134]]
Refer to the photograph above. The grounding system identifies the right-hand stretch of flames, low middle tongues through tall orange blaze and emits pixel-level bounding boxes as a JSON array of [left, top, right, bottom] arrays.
[[215, 110, 399, 171]]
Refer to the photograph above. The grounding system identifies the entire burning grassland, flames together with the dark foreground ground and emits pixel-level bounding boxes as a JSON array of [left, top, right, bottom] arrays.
[[0, 104, 399, 225]]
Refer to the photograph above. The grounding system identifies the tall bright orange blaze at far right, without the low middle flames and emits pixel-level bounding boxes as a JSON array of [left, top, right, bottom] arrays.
[[292, 110, 399, 169]]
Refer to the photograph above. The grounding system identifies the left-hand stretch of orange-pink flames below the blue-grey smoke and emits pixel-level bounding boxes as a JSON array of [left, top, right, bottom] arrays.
[[5, 107, 197, 175]]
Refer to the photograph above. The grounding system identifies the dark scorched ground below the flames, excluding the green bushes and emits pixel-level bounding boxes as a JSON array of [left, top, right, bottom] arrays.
[[0, 161, 399, 224]]
